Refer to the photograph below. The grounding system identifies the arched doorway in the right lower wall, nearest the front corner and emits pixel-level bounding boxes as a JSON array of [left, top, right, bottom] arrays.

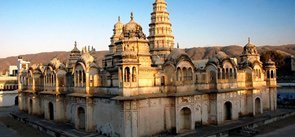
[[179, 107, 191, 131]]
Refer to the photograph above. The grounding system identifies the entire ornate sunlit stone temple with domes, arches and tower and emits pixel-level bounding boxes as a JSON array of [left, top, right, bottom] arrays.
[[19, 0, 277, 137]]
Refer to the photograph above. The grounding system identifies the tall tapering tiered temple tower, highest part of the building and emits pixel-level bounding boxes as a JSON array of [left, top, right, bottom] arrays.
[[148, 0, 174, 65]]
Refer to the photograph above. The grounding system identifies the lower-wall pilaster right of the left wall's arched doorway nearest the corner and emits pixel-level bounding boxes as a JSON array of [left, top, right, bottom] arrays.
[[85, 97, 95, 132]]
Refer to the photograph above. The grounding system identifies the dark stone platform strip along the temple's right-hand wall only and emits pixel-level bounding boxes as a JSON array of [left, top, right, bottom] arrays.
[[176, 109, 295, 137]]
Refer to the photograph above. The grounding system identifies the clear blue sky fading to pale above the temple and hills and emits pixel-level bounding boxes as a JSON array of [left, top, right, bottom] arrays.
[[0, 0, 295, 58]]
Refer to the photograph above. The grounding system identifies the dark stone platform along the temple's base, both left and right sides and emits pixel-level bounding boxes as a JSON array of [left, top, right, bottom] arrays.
[[10, 109, 295, 137]]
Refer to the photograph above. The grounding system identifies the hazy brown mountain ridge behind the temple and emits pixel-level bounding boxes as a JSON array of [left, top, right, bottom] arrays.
[[0, 44, 295, 72]]
